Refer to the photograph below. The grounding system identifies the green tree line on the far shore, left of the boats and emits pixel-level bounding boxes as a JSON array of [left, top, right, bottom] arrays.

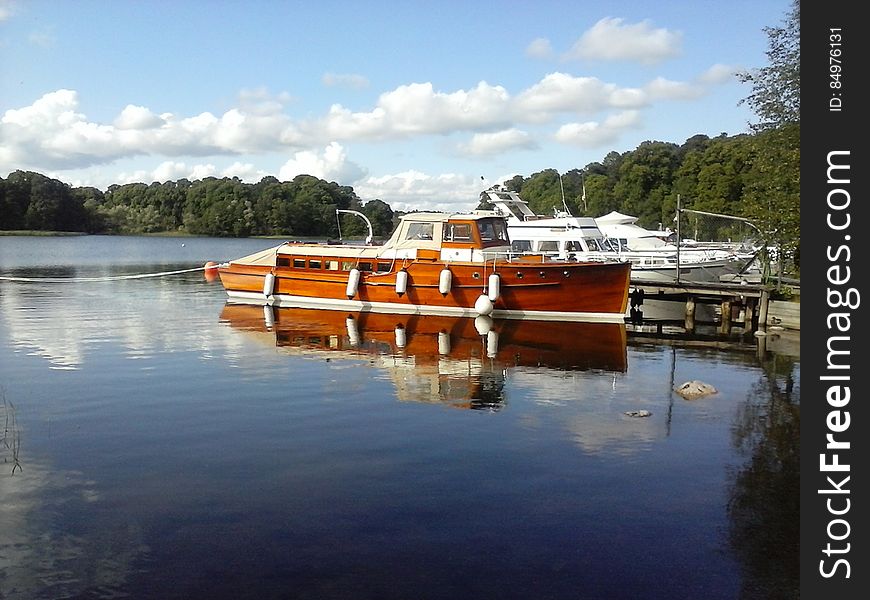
[[0, 171, 393, 238]]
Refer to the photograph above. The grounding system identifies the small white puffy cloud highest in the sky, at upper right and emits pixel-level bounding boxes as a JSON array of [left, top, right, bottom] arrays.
[[564, 17, 682, 64]]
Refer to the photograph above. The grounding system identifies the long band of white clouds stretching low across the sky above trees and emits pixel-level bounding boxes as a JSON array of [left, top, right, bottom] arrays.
[[0, 66, 708, 185]]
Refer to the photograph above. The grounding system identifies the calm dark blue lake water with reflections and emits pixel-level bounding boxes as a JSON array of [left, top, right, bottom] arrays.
[[0, 237, 800, 600]]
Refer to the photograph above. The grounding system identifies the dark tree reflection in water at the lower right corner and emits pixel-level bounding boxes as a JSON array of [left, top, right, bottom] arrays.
[[728, 355, 800, 599]]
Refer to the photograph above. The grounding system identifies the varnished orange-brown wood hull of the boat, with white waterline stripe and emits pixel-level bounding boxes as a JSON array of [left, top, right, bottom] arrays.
[[219, 260, 630, 322]]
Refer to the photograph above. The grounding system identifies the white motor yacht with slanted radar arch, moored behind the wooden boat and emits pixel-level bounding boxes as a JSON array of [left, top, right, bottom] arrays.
[[486, 187, 747, 282]]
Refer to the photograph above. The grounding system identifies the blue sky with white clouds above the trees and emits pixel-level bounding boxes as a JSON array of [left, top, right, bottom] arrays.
[[0, 0, 791, 211]]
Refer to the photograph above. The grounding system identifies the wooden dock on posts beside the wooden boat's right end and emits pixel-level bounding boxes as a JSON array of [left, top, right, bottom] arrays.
[[629, 278, 800, 334]]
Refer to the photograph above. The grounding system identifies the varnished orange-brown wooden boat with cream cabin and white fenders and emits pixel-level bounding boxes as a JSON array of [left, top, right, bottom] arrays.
[[218, 211, 629, 322]]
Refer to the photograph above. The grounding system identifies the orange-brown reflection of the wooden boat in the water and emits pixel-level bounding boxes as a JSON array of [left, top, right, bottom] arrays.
[[220, 303, 627, 410]]
